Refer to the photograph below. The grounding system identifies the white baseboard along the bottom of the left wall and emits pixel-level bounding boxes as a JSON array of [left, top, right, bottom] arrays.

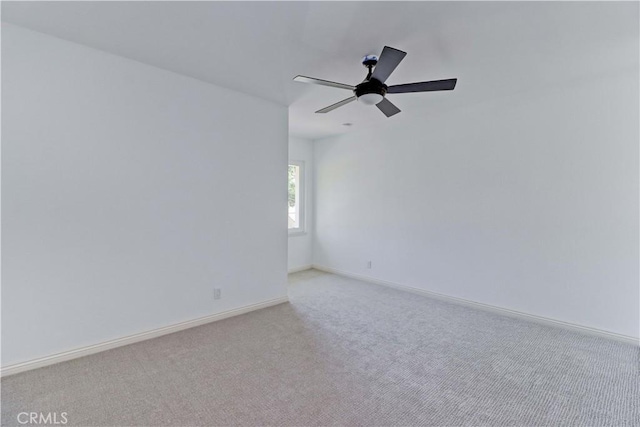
[[0, 296, 289, 377]]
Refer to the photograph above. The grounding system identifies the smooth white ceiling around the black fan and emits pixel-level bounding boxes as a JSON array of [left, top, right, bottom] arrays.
[[2, 1, 639, 139]]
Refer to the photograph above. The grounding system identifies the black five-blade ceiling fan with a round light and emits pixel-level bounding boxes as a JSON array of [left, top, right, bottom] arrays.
[[293, 46, 458, 117]]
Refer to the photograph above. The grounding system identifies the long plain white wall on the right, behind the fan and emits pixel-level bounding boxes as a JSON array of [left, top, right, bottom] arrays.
[[314, 66, 639, 337]]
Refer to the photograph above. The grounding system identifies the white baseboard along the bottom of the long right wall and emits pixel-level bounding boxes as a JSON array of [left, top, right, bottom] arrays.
[[313, 264, 640, 346]]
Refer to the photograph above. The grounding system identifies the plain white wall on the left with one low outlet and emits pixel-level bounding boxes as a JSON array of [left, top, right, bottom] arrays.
[[2, 23, 288, 366]]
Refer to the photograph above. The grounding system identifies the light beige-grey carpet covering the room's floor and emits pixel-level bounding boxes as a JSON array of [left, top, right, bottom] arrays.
[[2, 270, 640, 426]]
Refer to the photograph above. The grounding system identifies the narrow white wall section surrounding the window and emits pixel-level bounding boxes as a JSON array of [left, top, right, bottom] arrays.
[[288, 137, 314, 271]]
